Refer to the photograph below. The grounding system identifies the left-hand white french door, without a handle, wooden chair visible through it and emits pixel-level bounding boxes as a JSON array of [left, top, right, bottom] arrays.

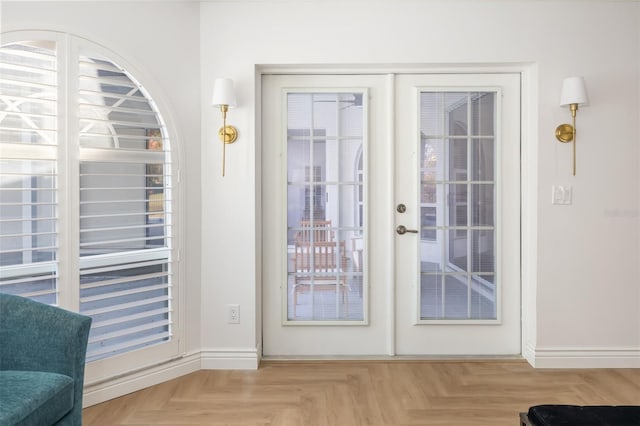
[[262, 75, 393, 355]]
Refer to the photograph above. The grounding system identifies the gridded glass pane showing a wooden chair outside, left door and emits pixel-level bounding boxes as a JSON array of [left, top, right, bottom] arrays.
[[287, 92, 365, 322]]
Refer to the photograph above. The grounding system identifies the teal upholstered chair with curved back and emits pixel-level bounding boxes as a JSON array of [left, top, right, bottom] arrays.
[[0, 294, 91, 426]]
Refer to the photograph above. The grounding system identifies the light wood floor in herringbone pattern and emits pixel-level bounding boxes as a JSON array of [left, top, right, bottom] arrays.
[[84, 360, 640, 426]]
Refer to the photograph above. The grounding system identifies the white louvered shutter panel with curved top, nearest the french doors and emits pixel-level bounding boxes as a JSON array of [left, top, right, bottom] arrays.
[[78, 52, 172, 360]]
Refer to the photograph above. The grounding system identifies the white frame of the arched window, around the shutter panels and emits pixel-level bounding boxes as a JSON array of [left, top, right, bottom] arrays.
[[2, 30, 185, 387]]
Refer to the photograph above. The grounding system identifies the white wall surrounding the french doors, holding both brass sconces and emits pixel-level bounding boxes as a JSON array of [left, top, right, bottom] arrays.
[[201, 0, 640, 366]]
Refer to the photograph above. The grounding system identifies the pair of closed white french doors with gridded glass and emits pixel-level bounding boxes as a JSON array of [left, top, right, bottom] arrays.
[[262, 70, 520, 356]]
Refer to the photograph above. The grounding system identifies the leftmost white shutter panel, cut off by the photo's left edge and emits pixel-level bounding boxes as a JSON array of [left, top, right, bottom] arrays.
[[0, 42, 58, 304]]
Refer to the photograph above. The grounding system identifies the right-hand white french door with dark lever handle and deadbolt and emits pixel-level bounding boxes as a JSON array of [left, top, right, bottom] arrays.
[[395, 74, 521, 355]]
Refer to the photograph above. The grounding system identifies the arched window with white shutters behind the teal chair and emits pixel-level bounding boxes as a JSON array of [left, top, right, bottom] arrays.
[[0, 33, 179, 369]]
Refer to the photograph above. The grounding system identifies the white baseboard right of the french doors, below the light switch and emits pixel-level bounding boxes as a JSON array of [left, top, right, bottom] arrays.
[[527, 347, 640, 368]]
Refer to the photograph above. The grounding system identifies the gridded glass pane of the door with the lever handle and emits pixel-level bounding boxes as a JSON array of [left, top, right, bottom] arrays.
[[419, 92, 497, 320]]
